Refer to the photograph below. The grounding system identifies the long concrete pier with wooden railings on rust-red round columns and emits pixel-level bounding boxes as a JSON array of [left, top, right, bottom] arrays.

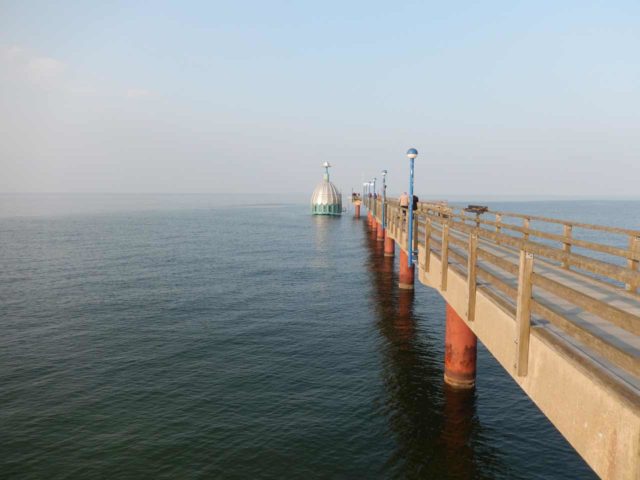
[[356, 195, 640, 480]]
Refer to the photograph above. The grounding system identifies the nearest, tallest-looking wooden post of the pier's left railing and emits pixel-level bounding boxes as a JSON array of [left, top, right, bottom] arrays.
[[514, 250, 533, 377]]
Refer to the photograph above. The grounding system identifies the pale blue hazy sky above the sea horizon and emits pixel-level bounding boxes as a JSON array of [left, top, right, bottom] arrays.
[[0, 0, 640, 197]]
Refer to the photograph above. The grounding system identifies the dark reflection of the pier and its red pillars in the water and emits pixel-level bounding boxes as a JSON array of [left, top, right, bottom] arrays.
[[365, 223, 500, 479]]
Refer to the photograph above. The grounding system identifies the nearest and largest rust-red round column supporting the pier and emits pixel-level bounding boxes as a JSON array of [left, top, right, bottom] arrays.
[[444, 303, 478, 388]]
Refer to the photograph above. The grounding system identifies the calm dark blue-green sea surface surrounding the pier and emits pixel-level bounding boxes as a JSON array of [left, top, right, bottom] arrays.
[[0, 195, 640, 479]]
